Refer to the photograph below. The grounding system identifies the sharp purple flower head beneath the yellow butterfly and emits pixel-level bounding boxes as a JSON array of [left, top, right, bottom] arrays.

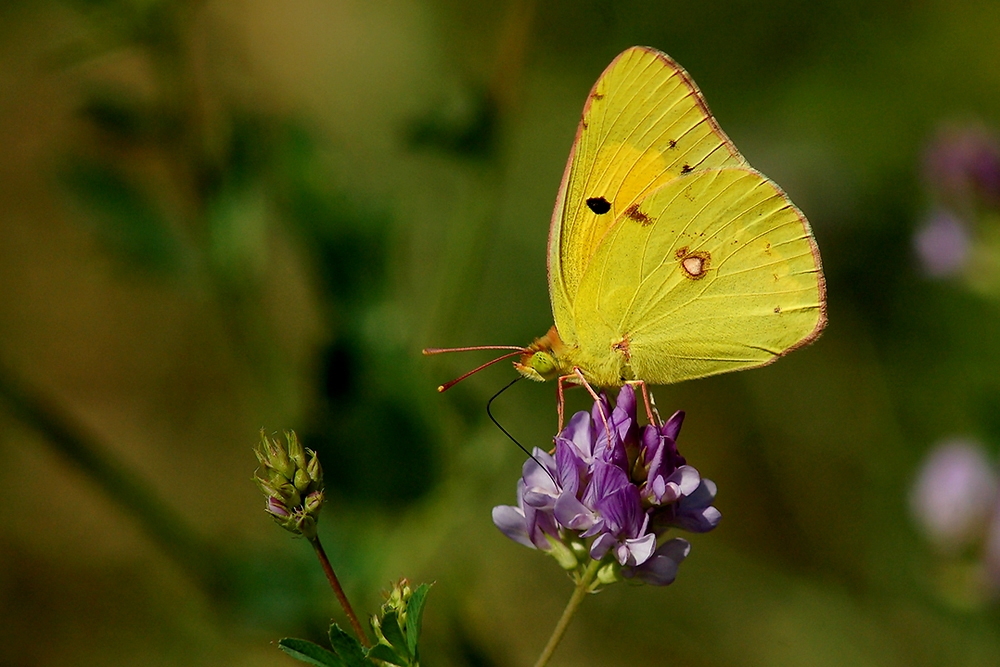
[[493, 385, 722, 585]]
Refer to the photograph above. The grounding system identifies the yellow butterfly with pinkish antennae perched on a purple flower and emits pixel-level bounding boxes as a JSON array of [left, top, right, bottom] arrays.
[[424, 47, 826, 424]]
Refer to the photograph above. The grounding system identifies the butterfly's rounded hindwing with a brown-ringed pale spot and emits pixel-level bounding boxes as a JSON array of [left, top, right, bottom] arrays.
[[573, 167, 826, 385]]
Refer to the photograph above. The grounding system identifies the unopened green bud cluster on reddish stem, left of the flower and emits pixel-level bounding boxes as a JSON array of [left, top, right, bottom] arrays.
[[254, 430, 324, 539]]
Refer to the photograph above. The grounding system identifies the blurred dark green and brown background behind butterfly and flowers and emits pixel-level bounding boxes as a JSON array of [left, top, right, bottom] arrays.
[[0, 0, 1000, 667]]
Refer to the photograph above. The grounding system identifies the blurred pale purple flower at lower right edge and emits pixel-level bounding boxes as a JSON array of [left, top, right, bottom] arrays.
[[910, 440, 1000, 557]]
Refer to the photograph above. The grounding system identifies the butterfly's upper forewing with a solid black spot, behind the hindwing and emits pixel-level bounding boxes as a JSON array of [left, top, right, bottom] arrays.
[[549, 47, 746, 345]]
